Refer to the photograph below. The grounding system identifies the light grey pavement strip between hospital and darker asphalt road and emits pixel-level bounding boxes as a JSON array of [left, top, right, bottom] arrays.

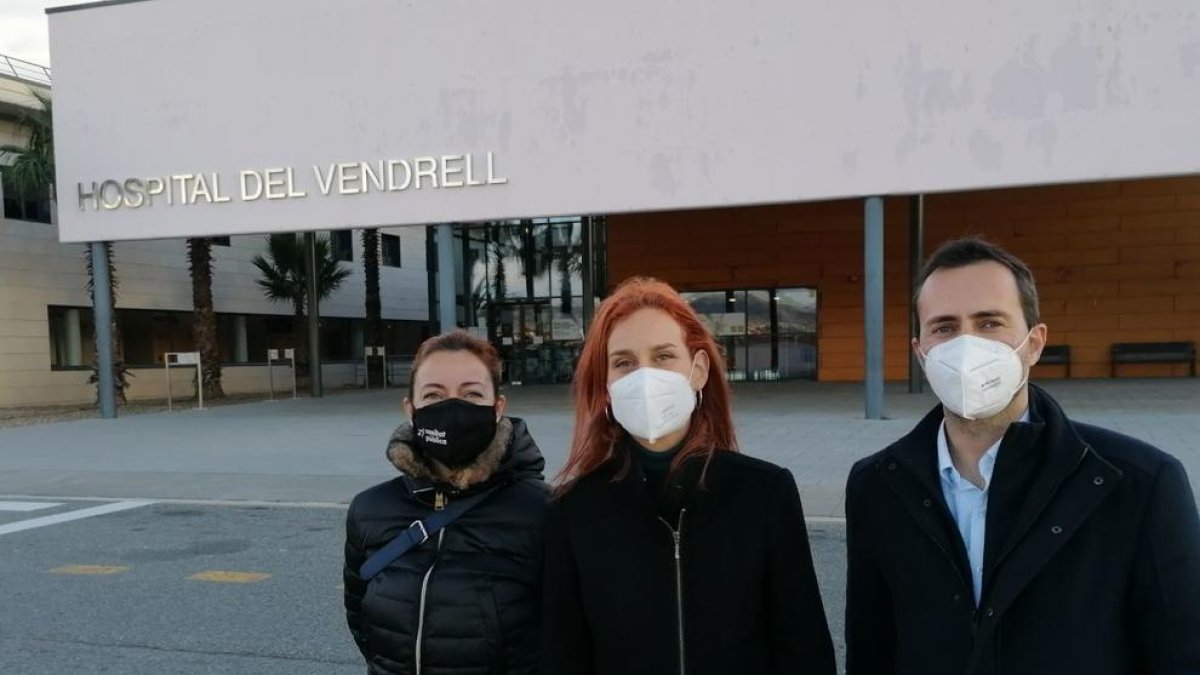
[[0, 378, 1200, 518]]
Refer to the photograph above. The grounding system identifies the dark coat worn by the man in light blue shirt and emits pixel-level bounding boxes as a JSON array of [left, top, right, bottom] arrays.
[[846, 387, 1200, 675]]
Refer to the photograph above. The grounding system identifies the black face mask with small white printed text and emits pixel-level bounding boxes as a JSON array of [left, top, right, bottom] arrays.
[[413, 399, 497, 468]]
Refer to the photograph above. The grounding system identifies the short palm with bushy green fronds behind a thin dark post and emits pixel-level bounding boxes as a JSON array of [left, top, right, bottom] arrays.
[[251, 234, 350, 374]]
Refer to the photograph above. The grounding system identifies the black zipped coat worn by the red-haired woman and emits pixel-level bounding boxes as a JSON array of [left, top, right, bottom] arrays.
[[541, 448, 836, 675]]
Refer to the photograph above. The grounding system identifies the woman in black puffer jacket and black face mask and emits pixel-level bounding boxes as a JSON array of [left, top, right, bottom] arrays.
[[343, 331, 548, 675]]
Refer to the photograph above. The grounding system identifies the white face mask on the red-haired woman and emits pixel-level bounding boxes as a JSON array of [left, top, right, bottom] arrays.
[[608, 366, 696, 443]]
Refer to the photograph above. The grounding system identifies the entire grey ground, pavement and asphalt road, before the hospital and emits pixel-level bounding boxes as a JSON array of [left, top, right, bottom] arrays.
[[0, 380, 1200, 675]]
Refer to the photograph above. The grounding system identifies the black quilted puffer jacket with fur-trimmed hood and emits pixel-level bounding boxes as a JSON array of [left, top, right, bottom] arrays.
[[343, 418, 550, 675]]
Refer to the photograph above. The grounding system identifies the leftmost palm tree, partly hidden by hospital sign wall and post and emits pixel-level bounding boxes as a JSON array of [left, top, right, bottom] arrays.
[[0, 89, 131, 402]]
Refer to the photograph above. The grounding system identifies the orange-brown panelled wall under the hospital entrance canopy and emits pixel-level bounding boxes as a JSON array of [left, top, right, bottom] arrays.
[[608, 177, 1200, 381]]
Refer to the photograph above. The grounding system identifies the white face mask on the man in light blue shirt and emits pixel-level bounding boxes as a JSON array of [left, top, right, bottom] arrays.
[[923, 330, 1033, 419]]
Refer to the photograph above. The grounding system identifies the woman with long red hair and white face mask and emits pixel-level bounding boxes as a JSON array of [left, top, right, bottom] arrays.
[[541, 279, 836, 675]]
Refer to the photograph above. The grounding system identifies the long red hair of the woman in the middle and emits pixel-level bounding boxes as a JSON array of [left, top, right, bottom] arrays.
[[558, 276, 737, 492]]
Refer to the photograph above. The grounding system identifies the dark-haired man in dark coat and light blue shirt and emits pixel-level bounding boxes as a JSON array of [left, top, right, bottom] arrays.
[[846, 239, 1200, 675]]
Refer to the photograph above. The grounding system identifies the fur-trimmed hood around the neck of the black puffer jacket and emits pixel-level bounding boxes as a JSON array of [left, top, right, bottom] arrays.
[[386, 417, 546, 491]]
